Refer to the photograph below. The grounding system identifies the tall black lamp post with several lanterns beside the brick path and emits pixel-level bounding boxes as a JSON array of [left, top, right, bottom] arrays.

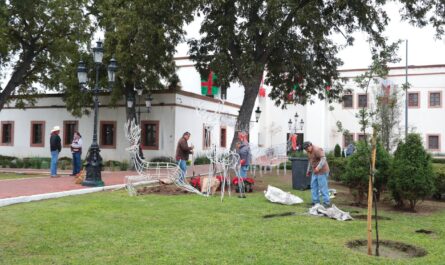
[[77, 41, 117, 187]]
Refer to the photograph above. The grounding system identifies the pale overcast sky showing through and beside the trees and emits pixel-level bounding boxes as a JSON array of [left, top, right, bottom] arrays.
[[176, 2, 445, 69]]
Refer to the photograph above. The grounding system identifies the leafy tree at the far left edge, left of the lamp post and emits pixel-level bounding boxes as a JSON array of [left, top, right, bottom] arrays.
[[0, 0, 91, 111]]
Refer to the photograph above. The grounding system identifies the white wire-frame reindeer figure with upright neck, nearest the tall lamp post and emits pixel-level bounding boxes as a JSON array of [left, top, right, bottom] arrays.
[[125, 120, 202, 196]]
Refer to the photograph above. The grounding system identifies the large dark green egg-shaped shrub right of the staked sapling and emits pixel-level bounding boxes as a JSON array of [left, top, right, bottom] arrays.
[[388, 134, 434, 211]]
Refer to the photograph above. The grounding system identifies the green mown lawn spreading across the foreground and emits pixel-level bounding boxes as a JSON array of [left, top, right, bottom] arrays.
[[0, 172, 445, 265]]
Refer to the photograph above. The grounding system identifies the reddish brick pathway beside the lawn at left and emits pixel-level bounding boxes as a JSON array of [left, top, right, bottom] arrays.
[[0, 165, 212, 199]]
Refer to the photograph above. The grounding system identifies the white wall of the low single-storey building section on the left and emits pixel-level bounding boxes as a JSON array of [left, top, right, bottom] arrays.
[[0, 92, 239, 161]]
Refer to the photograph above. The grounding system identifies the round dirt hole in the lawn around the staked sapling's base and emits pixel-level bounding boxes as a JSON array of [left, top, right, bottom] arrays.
[[346, 240, 428, 259]]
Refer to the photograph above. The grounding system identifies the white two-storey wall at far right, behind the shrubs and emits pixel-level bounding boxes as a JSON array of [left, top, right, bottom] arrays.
[[328, 66, 445, 153]]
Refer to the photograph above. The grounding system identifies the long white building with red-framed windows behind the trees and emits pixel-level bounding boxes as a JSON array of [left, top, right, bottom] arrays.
[[0, 63, 445, 161]]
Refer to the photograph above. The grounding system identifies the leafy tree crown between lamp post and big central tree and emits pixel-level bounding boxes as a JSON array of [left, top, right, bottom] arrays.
[[69, 0, 196, 119]]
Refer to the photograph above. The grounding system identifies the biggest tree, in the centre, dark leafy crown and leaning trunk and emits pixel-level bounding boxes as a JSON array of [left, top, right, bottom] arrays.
[[189, 0, 388, 148]]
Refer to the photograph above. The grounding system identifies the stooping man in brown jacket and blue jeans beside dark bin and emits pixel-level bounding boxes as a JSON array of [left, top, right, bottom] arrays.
[[303, 142, 331, 207]]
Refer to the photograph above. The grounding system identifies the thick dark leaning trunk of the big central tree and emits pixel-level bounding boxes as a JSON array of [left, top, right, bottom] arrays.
[[230, 77, 262, 150]]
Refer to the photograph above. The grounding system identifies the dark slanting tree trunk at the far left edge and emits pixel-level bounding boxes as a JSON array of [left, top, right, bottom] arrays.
[[0, 51, 34, 111]]
